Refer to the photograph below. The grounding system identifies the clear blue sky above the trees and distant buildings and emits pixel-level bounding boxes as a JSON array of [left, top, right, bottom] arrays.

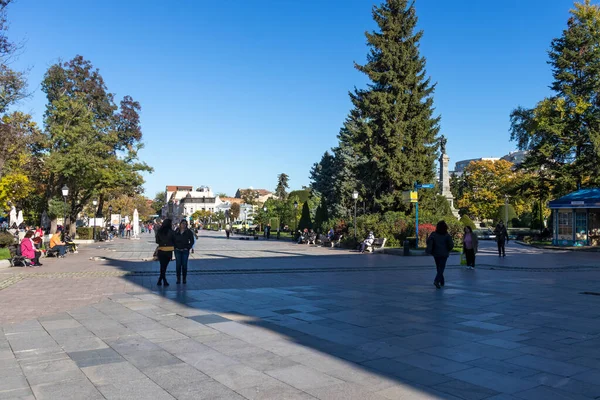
[[8, 0, 573, 197]]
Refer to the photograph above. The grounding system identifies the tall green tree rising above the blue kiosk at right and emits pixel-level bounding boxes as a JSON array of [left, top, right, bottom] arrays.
[[511, 0, 600, 194]]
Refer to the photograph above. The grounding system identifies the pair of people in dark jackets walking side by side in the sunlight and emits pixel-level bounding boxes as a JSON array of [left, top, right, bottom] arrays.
[[156, 219, 195, 286]]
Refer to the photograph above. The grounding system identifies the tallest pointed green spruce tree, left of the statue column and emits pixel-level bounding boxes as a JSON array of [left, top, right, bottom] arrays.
[[349, 0, 440, 211]]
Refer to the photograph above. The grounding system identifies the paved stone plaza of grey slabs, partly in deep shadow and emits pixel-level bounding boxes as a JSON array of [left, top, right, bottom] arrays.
[[0, 232, 600, 400]]
